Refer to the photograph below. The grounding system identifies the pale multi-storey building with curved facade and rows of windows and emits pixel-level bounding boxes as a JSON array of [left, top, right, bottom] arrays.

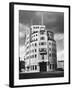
[[25, 25, 57, 72]]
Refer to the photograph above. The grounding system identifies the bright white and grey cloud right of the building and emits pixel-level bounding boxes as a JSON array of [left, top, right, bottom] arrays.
[[54, 33, 64, 60]]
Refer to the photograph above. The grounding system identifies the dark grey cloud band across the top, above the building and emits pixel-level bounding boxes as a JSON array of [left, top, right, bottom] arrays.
[[19, 10, 64, 33]]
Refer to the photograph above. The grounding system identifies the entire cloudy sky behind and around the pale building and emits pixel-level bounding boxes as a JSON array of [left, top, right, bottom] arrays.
[[19, 10, 64, 60]]
